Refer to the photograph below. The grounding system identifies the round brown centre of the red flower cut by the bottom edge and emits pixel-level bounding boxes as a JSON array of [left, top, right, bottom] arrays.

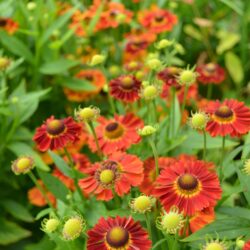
[[106, 226, 129, 248]]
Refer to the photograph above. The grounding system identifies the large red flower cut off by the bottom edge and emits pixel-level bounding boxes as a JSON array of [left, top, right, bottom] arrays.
[[87, 216, 152, 250]]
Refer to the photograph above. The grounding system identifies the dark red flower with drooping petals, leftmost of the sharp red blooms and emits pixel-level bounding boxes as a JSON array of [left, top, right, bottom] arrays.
[[33, 116, 82, 152]]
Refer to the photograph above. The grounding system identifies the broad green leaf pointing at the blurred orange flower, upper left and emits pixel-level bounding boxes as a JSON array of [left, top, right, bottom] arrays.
[[40, 59, 80, 75]]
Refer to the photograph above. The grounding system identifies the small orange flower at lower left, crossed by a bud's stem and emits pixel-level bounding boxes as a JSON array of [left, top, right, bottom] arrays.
[[28, 180, 56, 207]]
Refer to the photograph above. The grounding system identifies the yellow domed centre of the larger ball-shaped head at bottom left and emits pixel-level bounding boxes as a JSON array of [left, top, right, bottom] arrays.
[[63, 218, 83, 240]]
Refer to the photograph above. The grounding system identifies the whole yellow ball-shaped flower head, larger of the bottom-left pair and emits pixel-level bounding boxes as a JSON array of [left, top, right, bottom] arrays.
[[62, 215, 86, 240]]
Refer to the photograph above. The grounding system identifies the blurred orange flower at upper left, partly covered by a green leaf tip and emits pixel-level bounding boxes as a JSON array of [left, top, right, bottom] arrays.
[[63, 69, 106, 102]]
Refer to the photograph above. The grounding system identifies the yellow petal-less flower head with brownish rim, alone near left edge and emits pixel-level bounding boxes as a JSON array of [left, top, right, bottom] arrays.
[[11, 156, 35, 175]]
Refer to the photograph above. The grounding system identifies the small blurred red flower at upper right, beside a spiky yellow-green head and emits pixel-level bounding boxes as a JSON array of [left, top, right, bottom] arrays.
[[196, 63, 225, 84]]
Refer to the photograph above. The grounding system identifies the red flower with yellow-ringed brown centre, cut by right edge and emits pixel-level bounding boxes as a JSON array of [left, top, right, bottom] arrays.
[[206, 99, 250, 137]]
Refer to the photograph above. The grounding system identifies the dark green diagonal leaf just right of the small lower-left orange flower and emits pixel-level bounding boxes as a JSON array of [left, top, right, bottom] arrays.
[[38, 170, 69, 203]]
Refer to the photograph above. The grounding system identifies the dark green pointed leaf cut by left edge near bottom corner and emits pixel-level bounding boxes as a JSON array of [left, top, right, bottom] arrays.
[[0, 218, 31, 245]]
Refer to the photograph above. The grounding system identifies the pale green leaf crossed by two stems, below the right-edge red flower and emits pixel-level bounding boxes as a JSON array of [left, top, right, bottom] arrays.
[[182, 131, 239, 149]]
